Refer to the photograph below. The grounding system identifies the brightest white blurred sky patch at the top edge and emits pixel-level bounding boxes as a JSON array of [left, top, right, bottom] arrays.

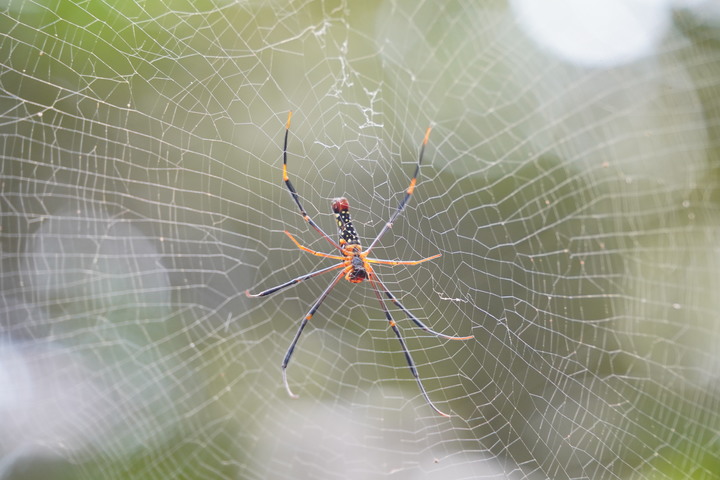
[[511, 0, 672, 67]]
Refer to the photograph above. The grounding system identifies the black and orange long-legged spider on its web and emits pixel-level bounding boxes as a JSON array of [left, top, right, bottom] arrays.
[[245, 112, 474, 417]]
